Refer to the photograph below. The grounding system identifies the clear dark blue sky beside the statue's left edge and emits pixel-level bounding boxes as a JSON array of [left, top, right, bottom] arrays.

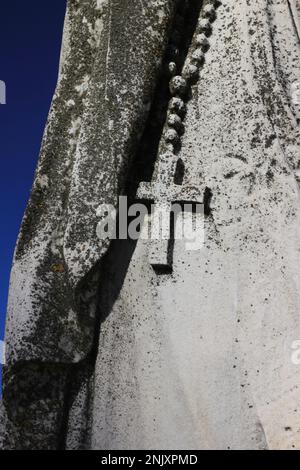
[[0, 0, 66, 360]]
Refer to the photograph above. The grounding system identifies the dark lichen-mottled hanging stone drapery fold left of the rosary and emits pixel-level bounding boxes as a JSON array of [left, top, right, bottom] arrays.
[[6, 0, 176, 365]]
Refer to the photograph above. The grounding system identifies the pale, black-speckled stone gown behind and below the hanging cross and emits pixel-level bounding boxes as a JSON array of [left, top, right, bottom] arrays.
[[92, 0, 300, 449]]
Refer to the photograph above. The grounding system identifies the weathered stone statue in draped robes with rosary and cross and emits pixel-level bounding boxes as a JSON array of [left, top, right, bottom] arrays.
[[0, 0, 300, 450]]
